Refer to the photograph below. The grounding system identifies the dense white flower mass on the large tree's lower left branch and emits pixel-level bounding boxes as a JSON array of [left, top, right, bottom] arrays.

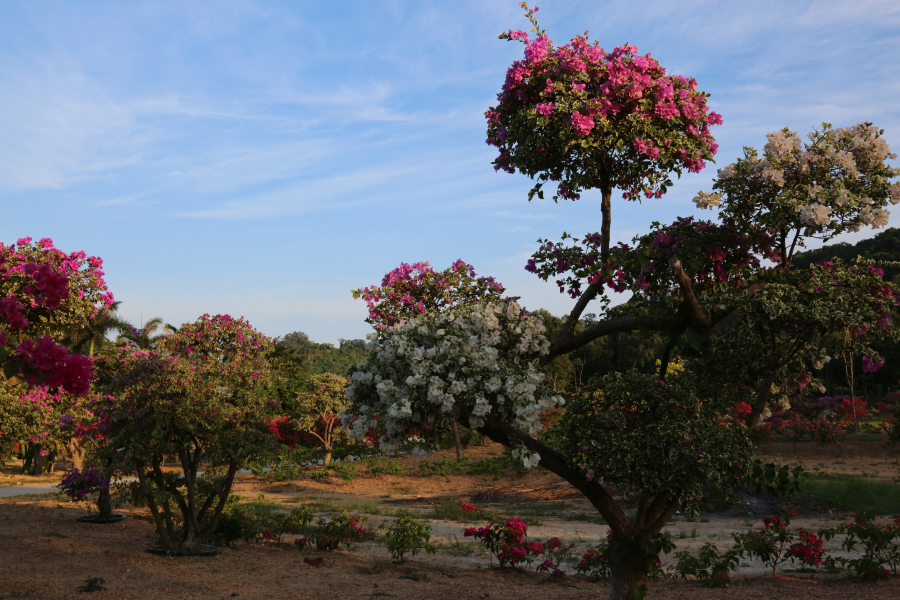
[[341, 301, 564, 466]]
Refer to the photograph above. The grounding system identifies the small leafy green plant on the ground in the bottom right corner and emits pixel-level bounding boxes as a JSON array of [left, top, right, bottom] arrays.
[[819, 511, 900, 582]]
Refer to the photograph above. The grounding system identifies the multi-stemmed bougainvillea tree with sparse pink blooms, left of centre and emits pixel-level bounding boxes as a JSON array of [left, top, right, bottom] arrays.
[[92, 315, 277, 554]]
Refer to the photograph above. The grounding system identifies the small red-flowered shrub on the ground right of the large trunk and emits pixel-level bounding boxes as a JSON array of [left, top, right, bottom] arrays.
[[732, 511, 825, 575]]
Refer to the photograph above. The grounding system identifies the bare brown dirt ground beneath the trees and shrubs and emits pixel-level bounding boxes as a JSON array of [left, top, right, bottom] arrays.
[[0, 442, 900, 600]]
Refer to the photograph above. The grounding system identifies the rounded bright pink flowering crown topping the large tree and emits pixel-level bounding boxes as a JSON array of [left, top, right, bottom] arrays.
[[485, 3, 722, 200]]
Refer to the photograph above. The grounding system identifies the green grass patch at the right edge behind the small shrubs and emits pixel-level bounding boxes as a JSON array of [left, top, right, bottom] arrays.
[[803, 476, 900, 516]]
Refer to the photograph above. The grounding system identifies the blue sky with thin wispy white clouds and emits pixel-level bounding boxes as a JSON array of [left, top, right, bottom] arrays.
[[0, 0, 900, 343]]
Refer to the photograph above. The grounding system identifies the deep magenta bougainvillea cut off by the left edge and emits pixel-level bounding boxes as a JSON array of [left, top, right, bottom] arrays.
[[0, 238, 113, 474]]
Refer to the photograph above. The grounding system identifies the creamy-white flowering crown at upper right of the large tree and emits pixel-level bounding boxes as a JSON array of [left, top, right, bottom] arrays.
[[694, 122, 900, 263]]
